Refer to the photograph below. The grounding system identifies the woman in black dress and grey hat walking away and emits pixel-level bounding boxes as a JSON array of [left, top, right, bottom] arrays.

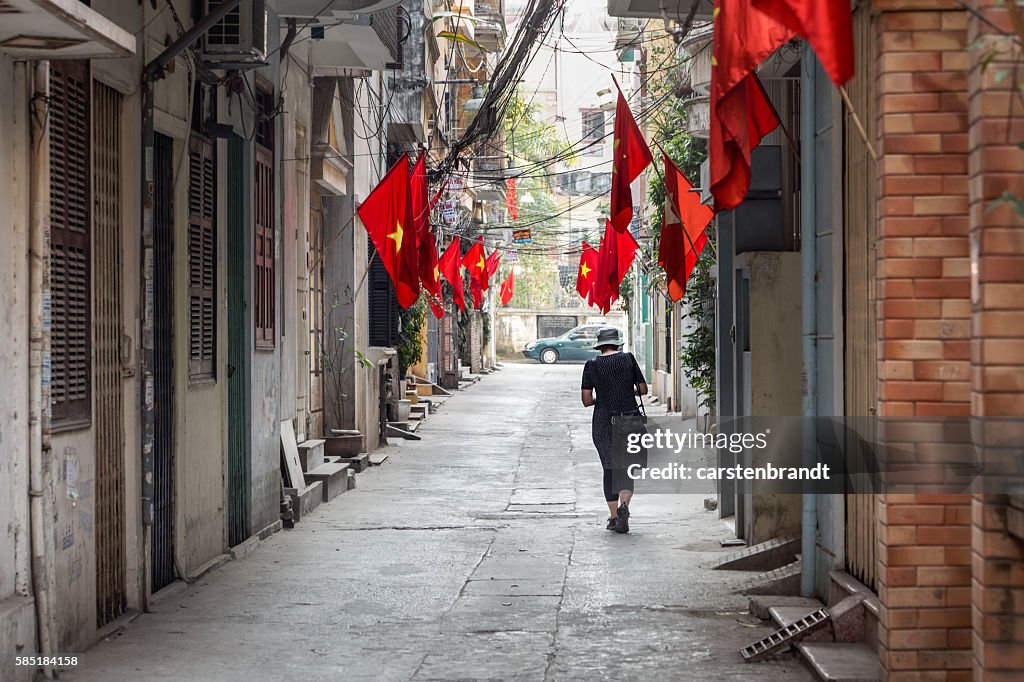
[[581, 328, 647, 532]]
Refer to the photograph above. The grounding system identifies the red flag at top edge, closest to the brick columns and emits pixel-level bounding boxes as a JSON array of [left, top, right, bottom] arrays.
[[753, 0, 854, 86]]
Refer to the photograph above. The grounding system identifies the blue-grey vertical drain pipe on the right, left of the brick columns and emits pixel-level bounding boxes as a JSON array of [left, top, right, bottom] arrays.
[[800, 42, 818, 597]]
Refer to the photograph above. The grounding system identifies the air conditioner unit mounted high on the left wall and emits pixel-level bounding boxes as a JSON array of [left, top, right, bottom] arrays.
[[202, 0, 267, 69]]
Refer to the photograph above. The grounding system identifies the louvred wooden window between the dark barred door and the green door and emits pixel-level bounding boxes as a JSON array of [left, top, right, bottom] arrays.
[[188, 133, 217, 380]]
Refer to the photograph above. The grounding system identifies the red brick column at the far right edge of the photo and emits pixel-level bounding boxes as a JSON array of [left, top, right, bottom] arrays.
[[968, 0, 1024, 682]]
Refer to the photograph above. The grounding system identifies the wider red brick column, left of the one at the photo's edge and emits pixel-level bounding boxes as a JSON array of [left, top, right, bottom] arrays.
[[872, 0, 972, 682]]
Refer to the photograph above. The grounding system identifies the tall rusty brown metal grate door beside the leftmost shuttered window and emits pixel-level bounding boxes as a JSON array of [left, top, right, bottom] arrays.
[[92, 83, 126, 627]]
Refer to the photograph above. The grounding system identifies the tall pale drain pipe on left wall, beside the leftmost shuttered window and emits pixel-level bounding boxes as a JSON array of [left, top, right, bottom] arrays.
[[26, 60, 54, 679]]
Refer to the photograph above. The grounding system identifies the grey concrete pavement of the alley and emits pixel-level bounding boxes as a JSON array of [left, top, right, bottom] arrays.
[[61, 365, 811, 682]]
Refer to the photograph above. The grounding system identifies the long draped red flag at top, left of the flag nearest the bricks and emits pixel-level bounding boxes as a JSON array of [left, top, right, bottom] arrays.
[[708, 0, 793, 211]]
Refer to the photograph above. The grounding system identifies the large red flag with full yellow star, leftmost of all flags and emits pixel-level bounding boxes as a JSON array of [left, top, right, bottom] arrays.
[[357, 154, 420, 308]]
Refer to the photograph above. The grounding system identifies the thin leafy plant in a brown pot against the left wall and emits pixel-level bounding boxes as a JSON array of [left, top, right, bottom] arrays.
[[316, 302, 373, 458]]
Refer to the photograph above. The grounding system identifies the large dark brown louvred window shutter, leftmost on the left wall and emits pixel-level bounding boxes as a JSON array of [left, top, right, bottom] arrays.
[[49, 61, 92, 428]]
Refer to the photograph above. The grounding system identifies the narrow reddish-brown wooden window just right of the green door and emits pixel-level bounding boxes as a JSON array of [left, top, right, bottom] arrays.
[[253, 87, 276, 349]]
